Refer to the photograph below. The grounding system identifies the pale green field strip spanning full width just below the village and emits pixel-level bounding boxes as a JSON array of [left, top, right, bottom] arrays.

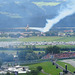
[[0, 36, 75, 42]]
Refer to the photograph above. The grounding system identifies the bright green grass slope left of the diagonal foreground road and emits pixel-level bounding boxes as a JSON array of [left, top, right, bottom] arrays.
[[24, 62, 62, 75]]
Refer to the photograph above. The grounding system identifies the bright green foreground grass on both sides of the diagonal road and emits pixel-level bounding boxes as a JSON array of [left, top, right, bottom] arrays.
[[9, 61, 75, 75]]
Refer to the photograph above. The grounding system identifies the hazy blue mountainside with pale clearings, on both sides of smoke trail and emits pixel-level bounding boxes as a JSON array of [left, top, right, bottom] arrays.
[[0, 0, 75, 31]]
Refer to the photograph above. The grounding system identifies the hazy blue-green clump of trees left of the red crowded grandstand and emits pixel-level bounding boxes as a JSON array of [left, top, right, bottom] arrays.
[[18, 50, 45, 61]]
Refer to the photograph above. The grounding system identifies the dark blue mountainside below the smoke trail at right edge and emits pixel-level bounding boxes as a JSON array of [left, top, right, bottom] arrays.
[[54, 14, 75, 27]]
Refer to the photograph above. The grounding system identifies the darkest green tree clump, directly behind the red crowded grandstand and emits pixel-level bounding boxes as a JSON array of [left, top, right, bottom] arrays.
[[45, 46, 60, 54]]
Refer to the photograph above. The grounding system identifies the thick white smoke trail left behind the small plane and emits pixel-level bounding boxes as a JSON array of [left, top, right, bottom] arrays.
[[29, 0, 75, 32]]
